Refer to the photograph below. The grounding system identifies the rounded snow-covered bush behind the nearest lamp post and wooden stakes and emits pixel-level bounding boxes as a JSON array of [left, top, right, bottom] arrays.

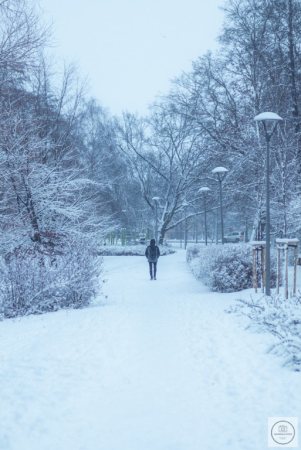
[[187, 244, 277, 292]]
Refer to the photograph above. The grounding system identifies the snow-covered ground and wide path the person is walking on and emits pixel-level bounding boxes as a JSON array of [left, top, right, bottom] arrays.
[[0, 250, 301, 450]]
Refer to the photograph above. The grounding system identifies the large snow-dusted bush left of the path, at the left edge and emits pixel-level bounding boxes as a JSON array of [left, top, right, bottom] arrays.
[[0, 240, 101, 317]]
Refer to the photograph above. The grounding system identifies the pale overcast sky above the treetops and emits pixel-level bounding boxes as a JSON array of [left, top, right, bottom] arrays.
[[39, 0, 223, 114]]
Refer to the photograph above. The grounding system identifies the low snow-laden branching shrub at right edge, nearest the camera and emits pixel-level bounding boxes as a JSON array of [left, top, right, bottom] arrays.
[[226, 294, 301, 372]]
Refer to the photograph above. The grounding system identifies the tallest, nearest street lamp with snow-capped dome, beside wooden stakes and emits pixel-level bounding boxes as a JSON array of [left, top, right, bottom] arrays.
[[254, 112, 283, 295]]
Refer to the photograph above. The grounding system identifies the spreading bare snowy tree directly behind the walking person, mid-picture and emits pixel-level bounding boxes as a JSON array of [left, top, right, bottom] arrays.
[[118, 98, 209, 242]]
